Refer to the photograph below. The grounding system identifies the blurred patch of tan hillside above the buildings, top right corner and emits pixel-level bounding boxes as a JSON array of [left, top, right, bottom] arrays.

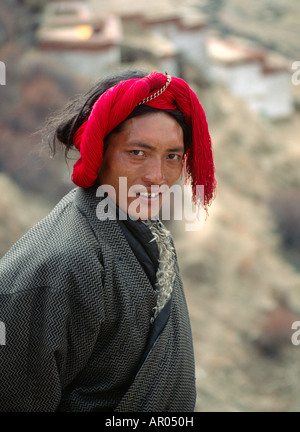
[[198, 0, 300, 60]]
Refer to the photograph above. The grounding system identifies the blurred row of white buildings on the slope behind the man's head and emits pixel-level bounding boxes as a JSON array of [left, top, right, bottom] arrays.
[[37, 0, 293, 119]]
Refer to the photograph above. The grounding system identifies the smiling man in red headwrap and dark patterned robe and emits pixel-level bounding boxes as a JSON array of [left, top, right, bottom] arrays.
[[0, 71, 215, 412]]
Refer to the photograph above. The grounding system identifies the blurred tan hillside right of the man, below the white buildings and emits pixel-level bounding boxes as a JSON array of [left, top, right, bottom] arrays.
[[174, 83, 300, 411]]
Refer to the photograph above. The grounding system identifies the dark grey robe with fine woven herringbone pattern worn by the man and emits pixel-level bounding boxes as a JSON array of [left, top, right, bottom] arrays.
[[0, 188, 195, 412]]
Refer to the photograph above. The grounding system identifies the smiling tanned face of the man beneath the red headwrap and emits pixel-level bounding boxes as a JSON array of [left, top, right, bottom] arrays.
[[99, 112, 184, 220]]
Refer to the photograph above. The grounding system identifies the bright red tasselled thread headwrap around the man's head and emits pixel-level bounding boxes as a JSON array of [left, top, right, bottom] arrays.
[[72, 72, 216, 207]]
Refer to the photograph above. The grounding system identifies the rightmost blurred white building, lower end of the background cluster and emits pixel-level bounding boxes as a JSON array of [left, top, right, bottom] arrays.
[[208, 37, 293, 119]]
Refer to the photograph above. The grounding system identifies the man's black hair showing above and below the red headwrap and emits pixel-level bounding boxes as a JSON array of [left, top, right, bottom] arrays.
[[42, 70, 190, 159]]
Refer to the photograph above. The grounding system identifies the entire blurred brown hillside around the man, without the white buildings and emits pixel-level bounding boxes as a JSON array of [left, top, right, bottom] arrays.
[[0, 0, 300, 412]]
